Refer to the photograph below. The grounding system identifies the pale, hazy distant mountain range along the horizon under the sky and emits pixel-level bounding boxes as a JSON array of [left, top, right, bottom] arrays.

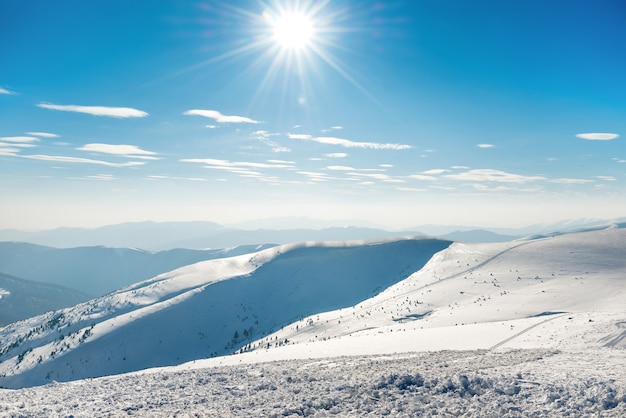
[[0, 217, 626, 250]]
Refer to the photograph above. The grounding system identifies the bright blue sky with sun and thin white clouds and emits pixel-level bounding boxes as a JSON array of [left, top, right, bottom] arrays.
[[0, 0, 626, 229]]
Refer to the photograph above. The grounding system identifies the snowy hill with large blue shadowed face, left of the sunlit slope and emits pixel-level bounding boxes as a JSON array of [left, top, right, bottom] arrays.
[[0, 239, 450, 387]]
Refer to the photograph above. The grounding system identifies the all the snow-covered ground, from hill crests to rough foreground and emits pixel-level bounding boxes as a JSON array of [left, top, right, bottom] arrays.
[[0, 225, 626, 417]]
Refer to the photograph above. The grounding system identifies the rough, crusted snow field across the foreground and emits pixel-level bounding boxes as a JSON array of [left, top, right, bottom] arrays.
[[0, 349, 626, 418]]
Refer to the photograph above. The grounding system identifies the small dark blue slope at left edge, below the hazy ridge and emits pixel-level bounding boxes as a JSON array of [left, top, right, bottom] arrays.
[[0, 273, 87, 326]]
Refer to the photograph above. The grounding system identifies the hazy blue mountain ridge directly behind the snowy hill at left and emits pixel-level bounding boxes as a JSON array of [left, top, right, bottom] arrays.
[[0, 242, 273, 296]]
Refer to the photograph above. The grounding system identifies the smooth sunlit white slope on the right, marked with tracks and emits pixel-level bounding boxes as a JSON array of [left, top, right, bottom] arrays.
[[247, 224, 626, 351]]
